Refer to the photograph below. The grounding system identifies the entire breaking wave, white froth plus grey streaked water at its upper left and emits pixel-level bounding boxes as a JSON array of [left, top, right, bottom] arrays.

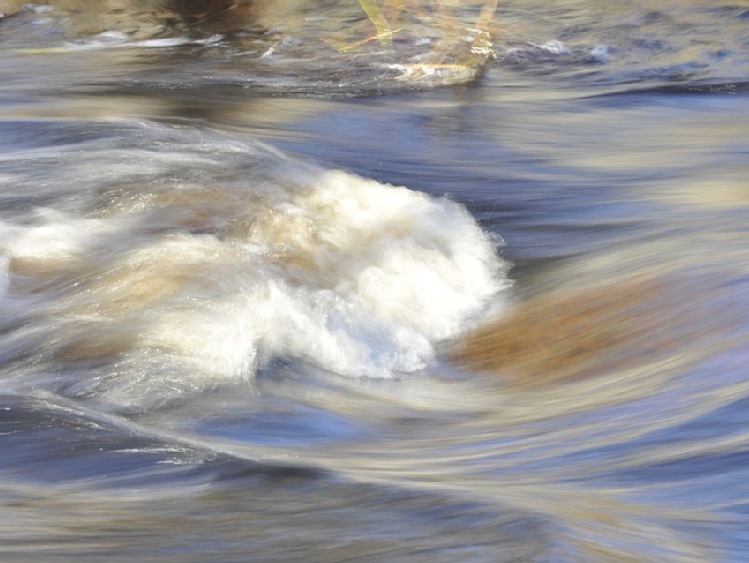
[[0, 123, 508, 408]]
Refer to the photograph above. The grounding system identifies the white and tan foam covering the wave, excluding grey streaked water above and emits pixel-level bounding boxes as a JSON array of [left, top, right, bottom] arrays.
[[0, 150, 507, 403]]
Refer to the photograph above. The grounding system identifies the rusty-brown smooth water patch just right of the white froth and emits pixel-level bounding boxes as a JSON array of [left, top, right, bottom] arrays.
[[450, 278, 731, 388]]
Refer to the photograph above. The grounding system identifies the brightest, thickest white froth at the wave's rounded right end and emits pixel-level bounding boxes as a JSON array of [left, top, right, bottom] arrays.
[[300, 172, 500, 340]]
